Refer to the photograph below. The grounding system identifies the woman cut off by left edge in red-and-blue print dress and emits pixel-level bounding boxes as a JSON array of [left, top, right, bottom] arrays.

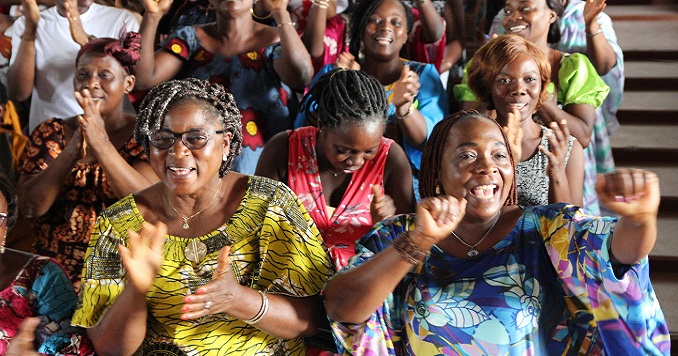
[[0, 175, 94, 355]]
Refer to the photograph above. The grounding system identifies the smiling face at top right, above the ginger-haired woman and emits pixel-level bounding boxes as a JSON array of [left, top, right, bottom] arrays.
[[501, 0, 557, 43]]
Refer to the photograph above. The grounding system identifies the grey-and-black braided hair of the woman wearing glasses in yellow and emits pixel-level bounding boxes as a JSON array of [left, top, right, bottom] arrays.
[[134, 78, 242, 177]]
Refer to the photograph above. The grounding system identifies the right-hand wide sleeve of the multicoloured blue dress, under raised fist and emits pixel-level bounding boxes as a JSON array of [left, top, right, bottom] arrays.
[[537, 204, 670, 355]]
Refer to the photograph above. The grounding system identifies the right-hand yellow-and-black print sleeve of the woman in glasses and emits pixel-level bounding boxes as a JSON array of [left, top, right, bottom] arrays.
[[259, 181, 334, 297]]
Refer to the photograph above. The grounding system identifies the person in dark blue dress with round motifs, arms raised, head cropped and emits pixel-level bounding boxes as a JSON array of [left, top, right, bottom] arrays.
[[137, 0, 313, 174]]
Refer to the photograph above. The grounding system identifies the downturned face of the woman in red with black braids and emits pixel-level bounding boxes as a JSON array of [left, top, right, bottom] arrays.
[[318, 120, 384, 174]]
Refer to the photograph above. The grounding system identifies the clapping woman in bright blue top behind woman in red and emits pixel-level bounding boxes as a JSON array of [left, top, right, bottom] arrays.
[[296, 0, 448, 200]]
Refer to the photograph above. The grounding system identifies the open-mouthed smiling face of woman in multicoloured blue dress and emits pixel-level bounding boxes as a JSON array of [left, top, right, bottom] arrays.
[[440, 117, 514, 218]]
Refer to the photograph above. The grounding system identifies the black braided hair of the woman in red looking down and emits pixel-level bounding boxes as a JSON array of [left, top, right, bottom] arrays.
[[301, 68, 388, 129]]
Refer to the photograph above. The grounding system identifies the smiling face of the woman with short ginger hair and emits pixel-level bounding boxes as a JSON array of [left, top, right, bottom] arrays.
[[490, 54, 541, 122]]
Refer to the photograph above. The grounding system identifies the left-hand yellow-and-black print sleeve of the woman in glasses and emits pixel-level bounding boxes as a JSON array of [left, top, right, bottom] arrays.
[[71, 211, 127, 328]]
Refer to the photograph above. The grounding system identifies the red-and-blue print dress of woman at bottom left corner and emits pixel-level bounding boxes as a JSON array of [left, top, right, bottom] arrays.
[[0, 255, 94, 355]]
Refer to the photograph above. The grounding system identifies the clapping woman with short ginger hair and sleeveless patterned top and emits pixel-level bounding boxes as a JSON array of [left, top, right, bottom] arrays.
[[468, 35, 584, 206]]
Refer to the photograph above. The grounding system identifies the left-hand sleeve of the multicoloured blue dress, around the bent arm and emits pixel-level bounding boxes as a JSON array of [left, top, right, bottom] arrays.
[[330, 215, 413, 355]]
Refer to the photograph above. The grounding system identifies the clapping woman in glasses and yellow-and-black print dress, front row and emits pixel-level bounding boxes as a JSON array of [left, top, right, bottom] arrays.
[[72, 78, 334, 355]]
